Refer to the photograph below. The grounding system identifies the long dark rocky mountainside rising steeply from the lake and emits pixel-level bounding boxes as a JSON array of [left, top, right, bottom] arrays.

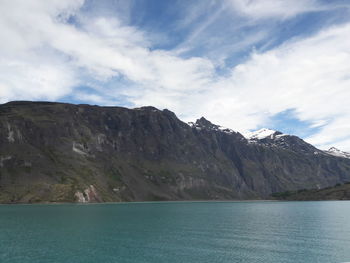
[[0, 102, 350, 202]]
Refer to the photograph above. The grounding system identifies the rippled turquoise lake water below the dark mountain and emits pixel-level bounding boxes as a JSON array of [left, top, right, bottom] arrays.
[[0, 201, 350, 263]]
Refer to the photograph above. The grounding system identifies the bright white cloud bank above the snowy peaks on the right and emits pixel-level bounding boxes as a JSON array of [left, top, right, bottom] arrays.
[[129, 24, 350, 150]]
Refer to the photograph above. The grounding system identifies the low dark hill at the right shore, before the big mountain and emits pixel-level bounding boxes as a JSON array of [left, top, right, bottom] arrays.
[[272, 183, 350, 201]]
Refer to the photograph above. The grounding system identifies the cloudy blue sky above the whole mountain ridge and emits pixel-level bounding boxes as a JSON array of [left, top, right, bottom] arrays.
[[0, 0, 350, 151]]
